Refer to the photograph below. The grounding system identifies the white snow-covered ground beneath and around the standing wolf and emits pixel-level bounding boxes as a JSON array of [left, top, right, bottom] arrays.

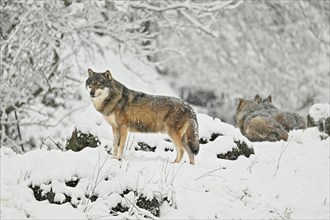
[[0, 40, 330, 219]]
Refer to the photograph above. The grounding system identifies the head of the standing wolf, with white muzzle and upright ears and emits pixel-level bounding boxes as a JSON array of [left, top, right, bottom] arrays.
[[86, 69, 112, 98]]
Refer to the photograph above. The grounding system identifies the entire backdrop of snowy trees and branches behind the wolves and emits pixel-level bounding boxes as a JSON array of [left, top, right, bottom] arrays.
[[0, 0, 330, 152]]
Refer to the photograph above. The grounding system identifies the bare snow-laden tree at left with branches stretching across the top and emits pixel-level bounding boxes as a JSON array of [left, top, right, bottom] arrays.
[[0, 0, 242, 152]]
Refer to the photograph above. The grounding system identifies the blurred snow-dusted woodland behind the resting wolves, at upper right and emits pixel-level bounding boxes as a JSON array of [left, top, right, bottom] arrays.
[[155, 0, 330, 123]]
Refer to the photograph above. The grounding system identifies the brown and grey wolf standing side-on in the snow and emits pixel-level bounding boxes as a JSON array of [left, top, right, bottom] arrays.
[[86, 69, 199, 164]]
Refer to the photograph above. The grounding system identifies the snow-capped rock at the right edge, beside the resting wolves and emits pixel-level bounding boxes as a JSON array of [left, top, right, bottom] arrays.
[[307, 103, 330, 135]]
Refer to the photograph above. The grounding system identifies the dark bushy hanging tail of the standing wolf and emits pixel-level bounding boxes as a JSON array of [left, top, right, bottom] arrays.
[[186, 115, 199, 155]]
